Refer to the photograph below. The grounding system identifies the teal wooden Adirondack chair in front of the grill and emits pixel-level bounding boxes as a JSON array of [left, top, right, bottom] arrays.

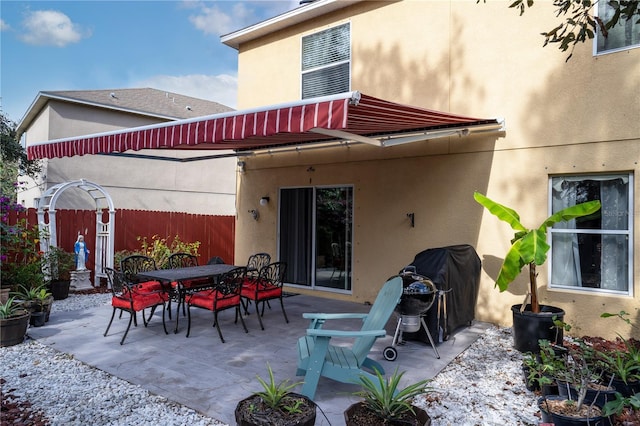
[[296, 277, 402, 399]]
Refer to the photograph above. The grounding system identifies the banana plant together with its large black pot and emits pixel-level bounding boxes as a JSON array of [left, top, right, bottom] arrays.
[[473, 192, 600, 352]]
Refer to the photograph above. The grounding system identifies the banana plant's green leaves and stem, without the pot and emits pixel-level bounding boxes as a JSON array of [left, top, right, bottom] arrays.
[[473, 192, 600, 313]]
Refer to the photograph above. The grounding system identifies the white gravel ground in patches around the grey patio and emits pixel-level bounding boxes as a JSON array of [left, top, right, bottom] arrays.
[[0, 294, 539, 426]]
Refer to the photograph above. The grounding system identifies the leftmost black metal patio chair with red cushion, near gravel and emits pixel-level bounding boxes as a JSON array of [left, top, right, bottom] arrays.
[[104, 268, 169, 345]]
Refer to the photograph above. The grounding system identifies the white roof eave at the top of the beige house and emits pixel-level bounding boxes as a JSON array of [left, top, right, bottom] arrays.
[[220, 0, 364, 50]]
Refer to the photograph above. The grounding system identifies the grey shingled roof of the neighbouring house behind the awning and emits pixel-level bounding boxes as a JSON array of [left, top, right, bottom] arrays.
[[17, 87, 233, 136]]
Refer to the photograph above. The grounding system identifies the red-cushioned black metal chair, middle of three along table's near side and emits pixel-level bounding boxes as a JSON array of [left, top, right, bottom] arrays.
[[185, 267, 249, 343]]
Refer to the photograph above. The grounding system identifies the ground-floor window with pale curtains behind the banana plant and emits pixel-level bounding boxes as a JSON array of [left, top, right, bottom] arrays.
[[549, 173, 633, 295]]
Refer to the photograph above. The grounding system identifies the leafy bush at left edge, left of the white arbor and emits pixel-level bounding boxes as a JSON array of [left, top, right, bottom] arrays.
[[0, 189, 44, 291]]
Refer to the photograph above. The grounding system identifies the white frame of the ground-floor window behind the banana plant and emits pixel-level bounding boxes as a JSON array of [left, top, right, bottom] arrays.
[[547, 172, 634, 297]]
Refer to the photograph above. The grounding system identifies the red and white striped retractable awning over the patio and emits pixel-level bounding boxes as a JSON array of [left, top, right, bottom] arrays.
[[27, 92, 500, 159]]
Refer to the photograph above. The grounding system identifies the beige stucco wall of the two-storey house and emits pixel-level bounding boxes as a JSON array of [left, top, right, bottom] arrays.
[[231, 0, 640, 337]]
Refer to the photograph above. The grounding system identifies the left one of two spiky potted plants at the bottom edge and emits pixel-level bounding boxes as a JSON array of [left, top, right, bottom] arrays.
[[235, 365, 316, 426]]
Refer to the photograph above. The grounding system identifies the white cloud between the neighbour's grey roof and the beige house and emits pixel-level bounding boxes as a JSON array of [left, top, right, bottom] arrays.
[[139, 74, 238, 108]]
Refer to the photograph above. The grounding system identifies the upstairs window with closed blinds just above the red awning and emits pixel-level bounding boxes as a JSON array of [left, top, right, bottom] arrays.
[[302, 23, 351, 99]]
